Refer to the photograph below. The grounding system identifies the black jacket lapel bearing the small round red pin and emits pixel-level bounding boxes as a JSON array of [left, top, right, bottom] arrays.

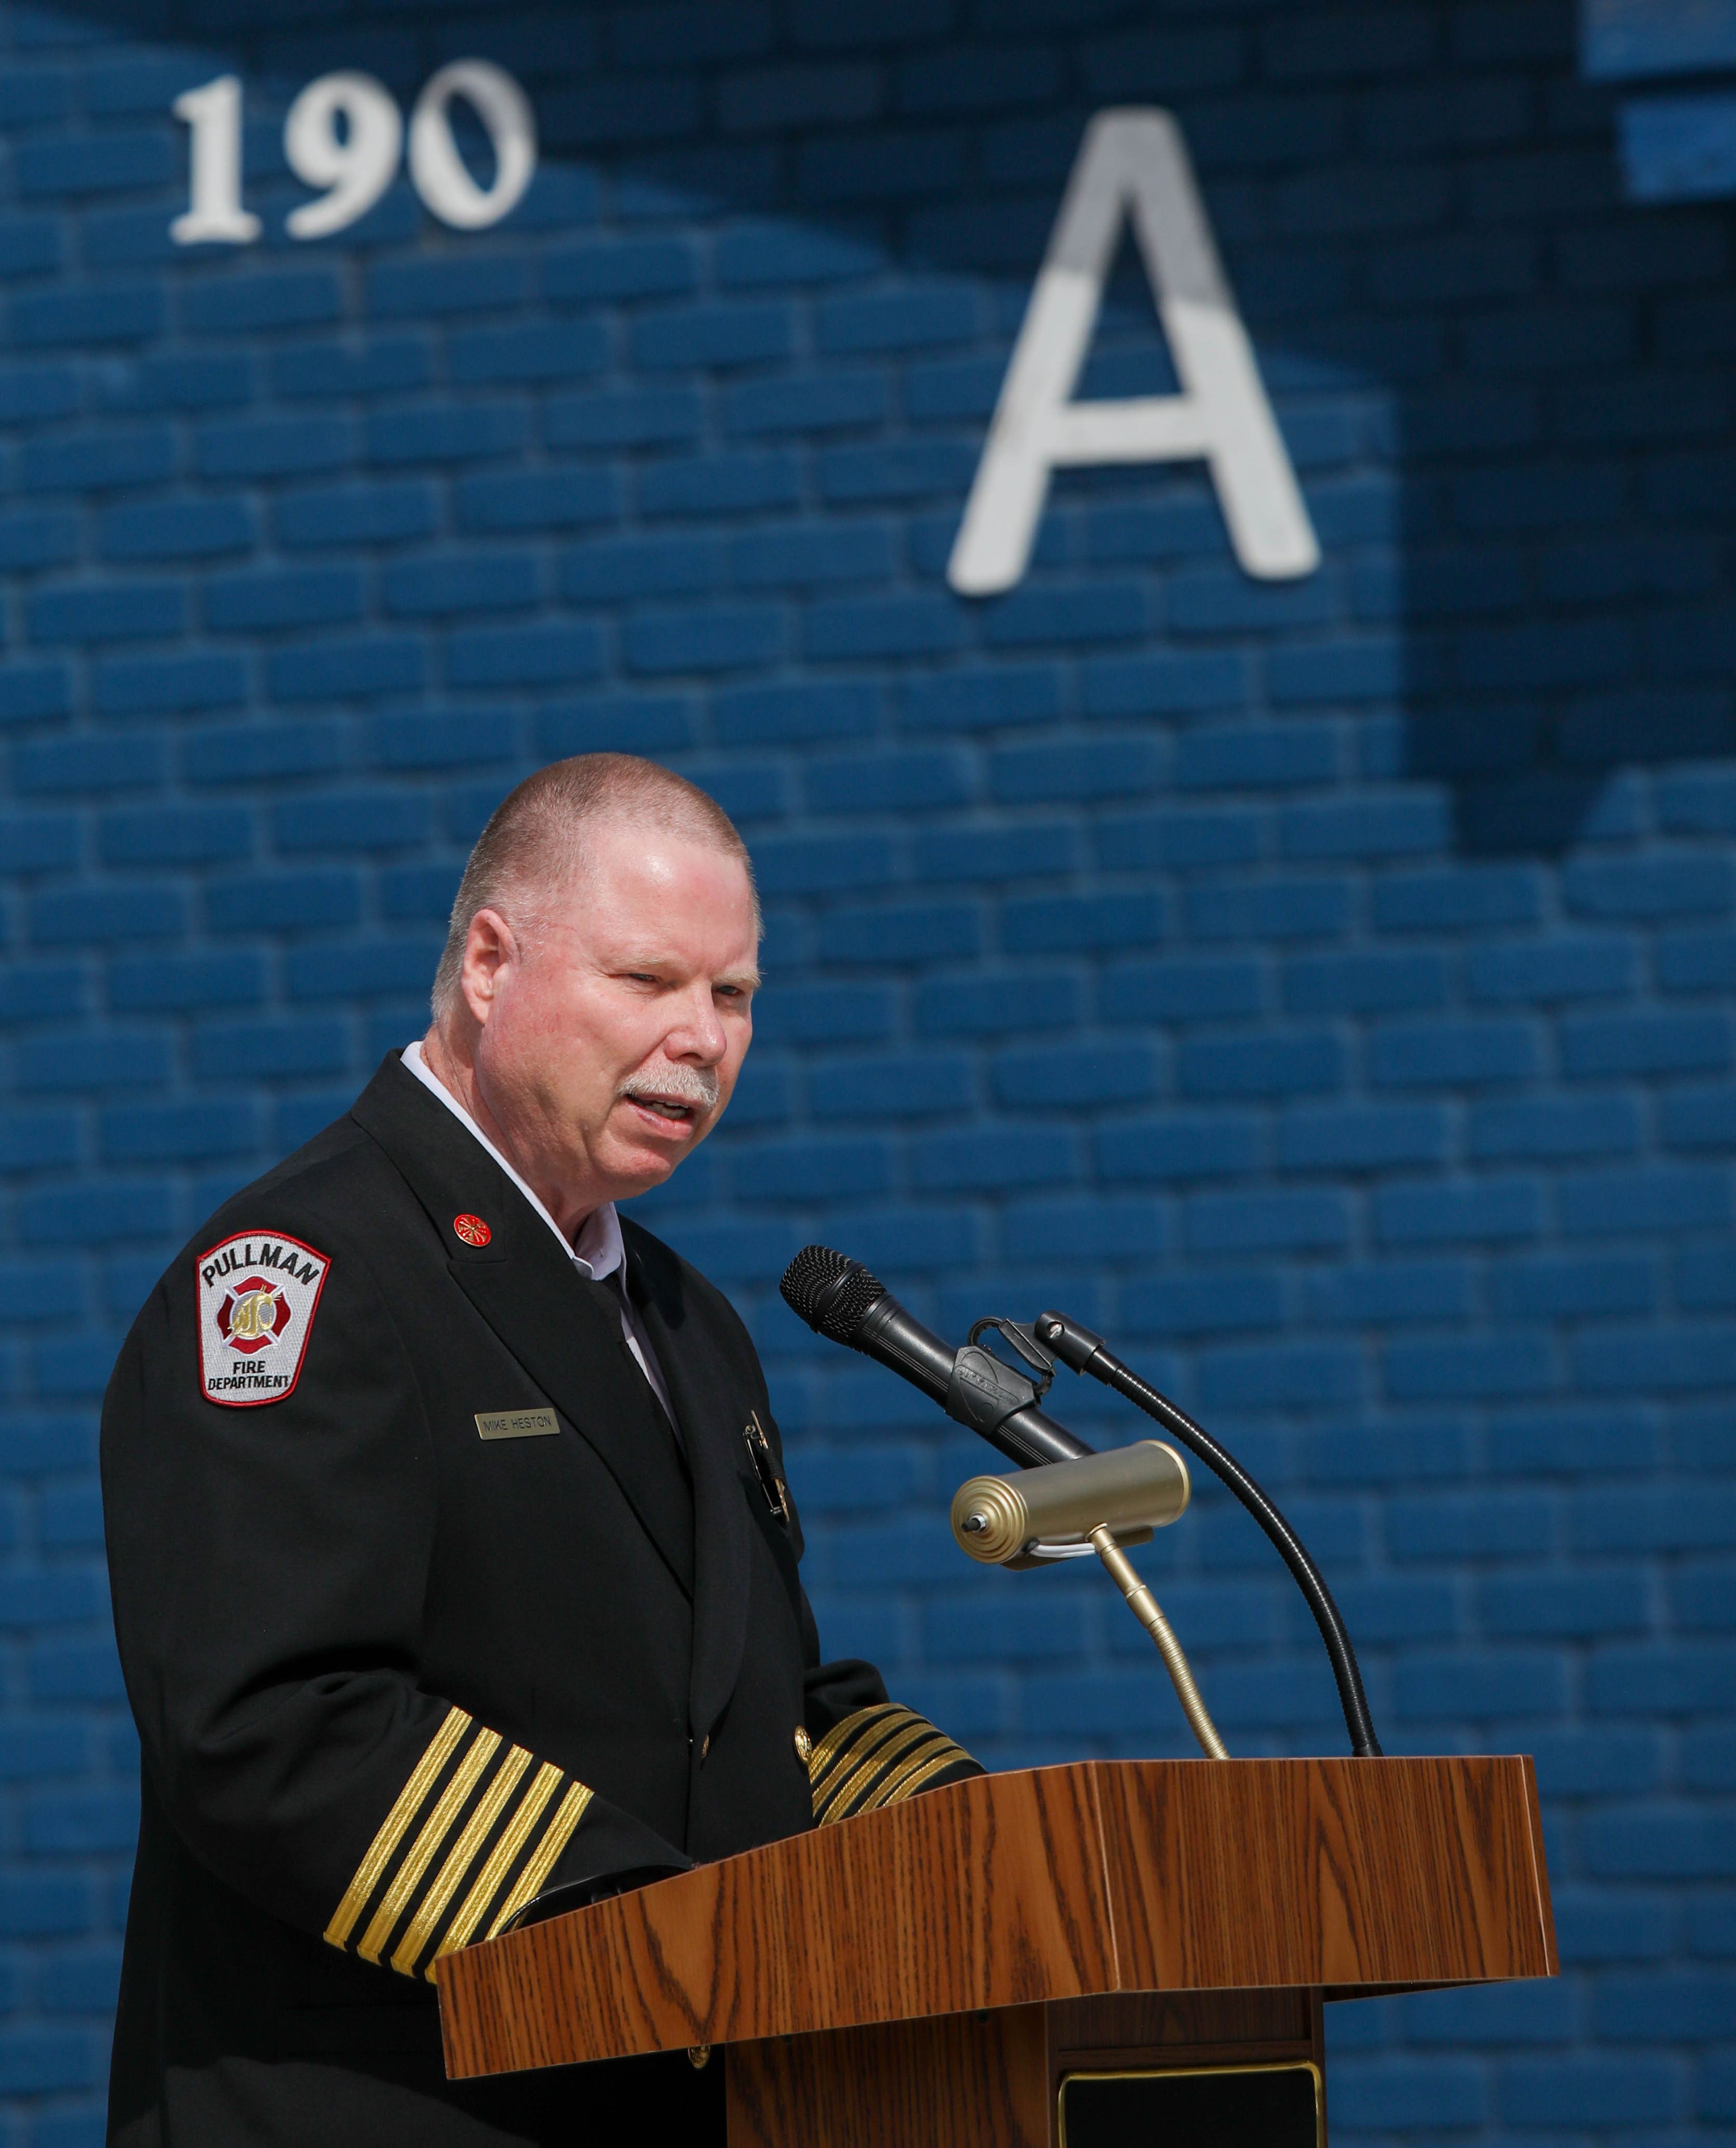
[[352, 1052, 696, 1596]]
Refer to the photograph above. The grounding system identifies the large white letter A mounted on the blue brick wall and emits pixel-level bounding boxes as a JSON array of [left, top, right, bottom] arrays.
[[948, 109, 1319, 597]]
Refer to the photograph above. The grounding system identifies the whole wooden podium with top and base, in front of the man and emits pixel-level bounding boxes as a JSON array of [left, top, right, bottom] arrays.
[[440, 1757, 1556, 2148]]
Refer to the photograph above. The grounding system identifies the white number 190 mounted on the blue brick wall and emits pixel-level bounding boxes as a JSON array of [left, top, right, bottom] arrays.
[[170, 60, 537, 247]]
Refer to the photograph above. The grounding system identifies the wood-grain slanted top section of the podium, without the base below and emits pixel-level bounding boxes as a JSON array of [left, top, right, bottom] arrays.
[[439, 1757, 1556, 2077]]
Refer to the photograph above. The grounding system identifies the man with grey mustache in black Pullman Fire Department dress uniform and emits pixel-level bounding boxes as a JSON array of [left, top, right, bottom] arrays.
[[103, 754, 977, 2148]]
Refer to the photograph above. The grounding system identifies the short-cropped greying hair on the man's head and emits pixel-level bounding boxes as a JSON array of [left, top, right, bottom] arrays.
[[432, 754, 760, 1022]]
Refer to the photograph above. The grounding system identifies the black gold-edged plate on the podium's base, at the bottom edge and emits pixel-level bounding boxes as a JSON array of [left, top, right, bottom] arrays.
[[1057, 2062, 1326, 2148]]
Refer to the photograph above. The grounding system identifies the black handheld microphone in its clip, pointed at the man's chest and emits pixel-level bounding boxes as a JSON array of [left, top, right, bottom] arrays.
[[778, 1246, 1094, 1469]]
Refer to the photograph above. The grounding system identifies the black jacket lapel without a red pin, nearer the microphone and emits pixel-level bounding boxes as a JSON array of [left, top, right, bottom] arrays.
[[621, 1218, 760, 1738]]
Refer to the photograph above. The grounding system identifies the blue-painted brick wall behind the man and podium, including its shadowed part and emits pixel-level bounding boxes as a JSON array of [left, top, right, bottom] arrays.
[[0, 0, 1736, 2148]]
